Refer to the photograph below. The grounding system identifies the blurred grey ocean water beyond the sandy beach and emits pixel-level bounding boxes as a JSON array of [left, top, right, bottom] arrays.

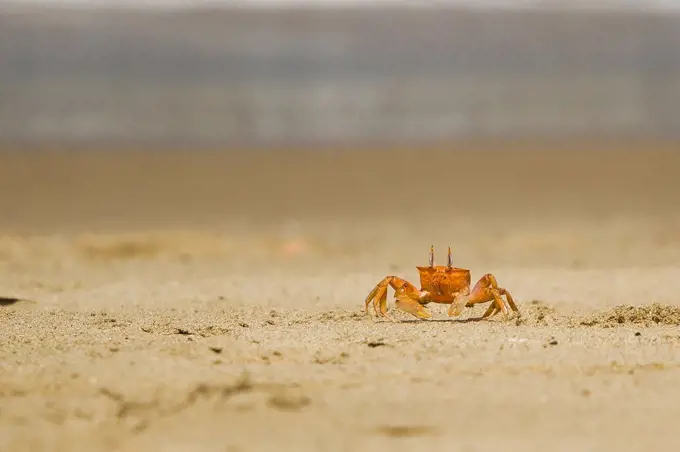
[[0, 0, 680, 148]]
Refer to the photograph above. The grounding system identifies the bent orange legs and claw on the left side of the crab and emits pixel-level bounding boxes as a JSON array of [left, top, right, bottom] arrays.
[[365, 276, 431, 321]]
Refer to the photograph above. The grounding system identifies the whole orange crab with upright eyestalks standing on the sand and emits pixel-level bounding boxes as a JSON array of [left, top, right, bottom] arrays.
[[366, 246, 519, 320]]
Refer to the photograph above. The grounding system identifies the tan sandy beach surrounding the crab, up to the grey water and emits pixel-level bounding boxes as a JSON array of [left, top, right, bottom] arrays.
[[0, 143, 680, 451]]
